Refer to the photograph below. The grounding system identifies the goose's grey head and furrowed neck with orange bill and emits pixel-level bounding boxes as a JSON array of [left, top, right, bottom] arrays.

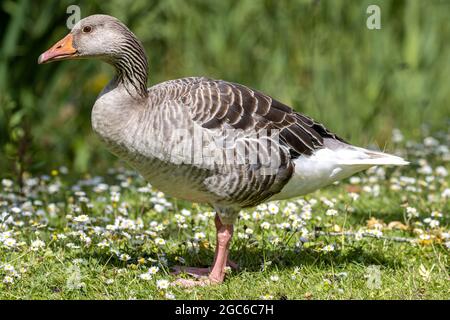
[[38, 14, 148, 97]]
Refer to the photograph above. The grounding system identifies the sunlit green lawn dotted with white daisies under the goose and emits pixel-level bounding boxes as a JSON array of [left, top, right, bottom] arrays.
[[0, 132, 450, 299]]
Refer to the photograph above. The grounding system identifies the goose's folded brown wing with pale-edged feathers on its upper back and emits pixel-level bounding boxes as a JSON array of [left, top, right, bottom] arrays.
[[182, 78, 345, 158]]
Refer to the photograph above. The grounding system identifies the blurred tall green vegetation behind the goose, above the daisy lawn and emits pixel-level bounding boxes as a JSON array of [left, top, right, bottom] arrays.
[[0, 0, 450, 177]]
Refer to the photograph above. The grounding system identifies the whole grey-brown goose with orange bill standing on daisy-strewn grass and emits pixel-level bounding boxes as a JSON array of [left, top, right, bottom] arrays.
[[38, 14, 408, 286]]
